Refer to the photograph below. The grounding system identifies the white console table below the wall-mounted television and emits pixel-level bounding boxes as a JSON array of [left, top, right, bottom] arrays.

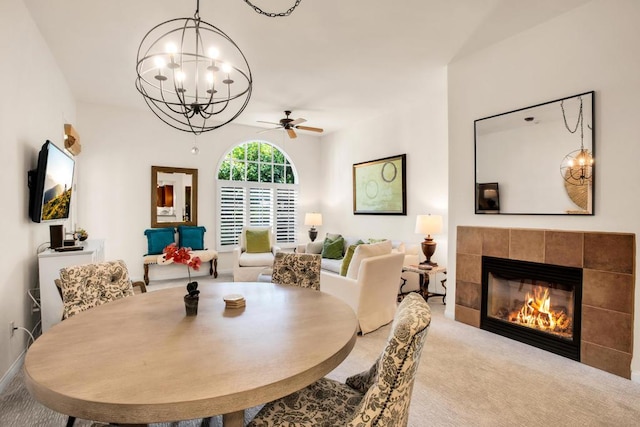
[[38, 240, 104, 333]]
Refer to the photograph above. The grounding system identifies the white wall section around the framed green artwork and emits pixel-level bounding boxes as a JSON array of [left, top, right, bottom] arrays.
[[319, 68, 448, 263]]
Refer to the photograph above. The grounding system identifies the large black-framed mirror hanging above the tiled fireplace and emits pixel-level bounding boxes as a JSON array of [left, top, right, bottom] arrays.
[[475, 91, 595, 215]]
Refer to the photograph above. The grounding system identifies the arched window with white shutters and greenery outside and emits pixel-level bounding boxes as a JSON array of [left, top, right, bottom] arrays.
[[217, 141, 298, 250]]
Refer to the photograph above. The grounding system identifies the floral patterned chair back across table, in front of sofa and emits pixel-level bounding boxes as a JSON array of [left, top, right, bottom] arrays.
[[271, 252, 322, 291]]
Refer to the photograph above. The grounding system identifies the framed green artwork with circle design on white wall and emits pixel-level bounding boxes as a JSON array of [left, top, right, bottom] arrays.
[[353, 154, 407, 215]]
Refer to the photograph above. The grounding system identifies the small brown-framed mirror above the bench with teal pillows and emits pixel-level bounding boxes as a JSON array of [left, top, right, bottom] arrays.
[[151, 166, 198, 228]]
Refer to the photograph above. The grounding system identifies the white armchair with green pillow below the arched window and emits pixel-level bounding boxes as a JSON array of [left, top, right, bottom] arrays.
[[233, 227, 280, 282]]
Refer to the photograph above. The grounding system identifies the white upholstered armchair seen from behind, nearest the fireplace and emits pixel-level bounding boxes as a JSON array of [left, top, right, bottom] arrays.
[[320, 253, 404, 334]]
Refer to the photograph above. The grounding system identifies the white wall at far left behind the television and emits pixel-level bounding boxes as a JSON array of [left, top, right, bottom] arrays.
[[0, 1, 75, 390]]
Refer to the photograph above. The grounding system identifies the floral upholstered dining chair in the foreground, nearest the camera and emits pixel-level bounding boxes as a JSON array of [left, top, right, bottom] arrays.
[[247, 293, 431, 427]]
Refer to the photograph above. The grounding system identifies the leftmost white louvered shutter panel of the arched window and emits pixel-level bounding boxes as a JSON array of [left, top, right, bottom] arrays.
[[219, 187, 246, 247]]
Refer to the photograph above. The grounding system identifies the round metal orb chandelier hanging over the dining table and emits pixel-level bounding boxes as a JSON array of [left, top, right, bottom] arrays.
[[136, 0, 253, 135]]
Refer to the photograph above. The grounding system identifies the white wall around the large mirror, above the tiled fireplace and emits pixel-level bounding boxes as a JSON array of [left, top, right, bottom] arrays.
[[446, 0, 640, 381]]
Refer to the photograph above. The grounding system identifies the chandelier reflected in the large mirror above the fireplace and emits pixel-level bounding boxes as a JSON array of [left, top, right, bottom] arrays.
[[560, 96, 593, 185]]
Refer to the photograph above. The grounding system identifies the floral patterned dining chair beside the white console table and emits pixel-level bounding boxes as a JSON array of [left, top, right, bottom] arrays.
[[55, 261, 146, 319]]
